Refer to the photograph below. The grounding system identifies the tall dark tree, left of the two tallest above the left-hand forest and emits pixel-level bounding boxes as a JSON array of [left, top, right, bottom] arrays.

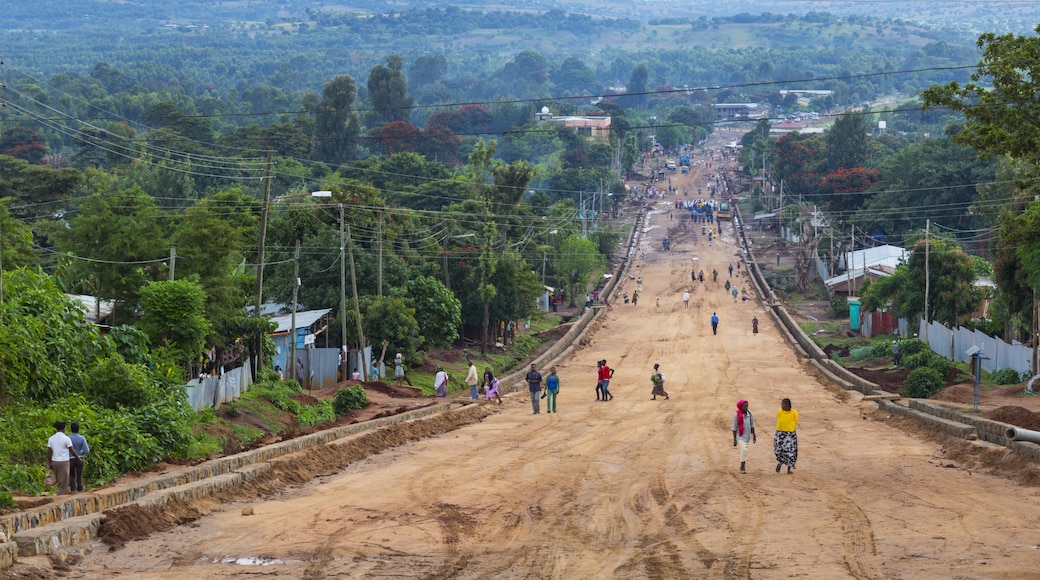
[[314, 75, 361, 165]]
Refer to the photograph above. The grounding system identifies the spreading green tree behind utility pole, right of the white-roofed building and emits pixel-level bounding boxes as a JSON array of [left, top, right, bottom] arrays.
[[863, 237, 979, 327]]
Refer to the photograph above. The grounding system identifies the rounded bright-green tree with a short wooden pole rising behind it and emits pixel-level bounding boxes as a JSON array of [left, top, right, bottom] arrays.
[[140, 280, 210, 366]]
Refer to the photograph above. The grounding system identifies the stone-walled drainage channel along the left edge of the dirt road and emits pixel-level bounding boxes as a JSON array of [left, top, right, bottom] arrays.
[[0, 211, 646, 570]]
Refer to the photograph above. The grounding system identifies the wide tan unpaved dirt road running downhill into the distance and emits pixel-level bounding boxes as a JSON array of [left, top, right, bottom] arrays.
[[67, 142, 1040, 580]]
